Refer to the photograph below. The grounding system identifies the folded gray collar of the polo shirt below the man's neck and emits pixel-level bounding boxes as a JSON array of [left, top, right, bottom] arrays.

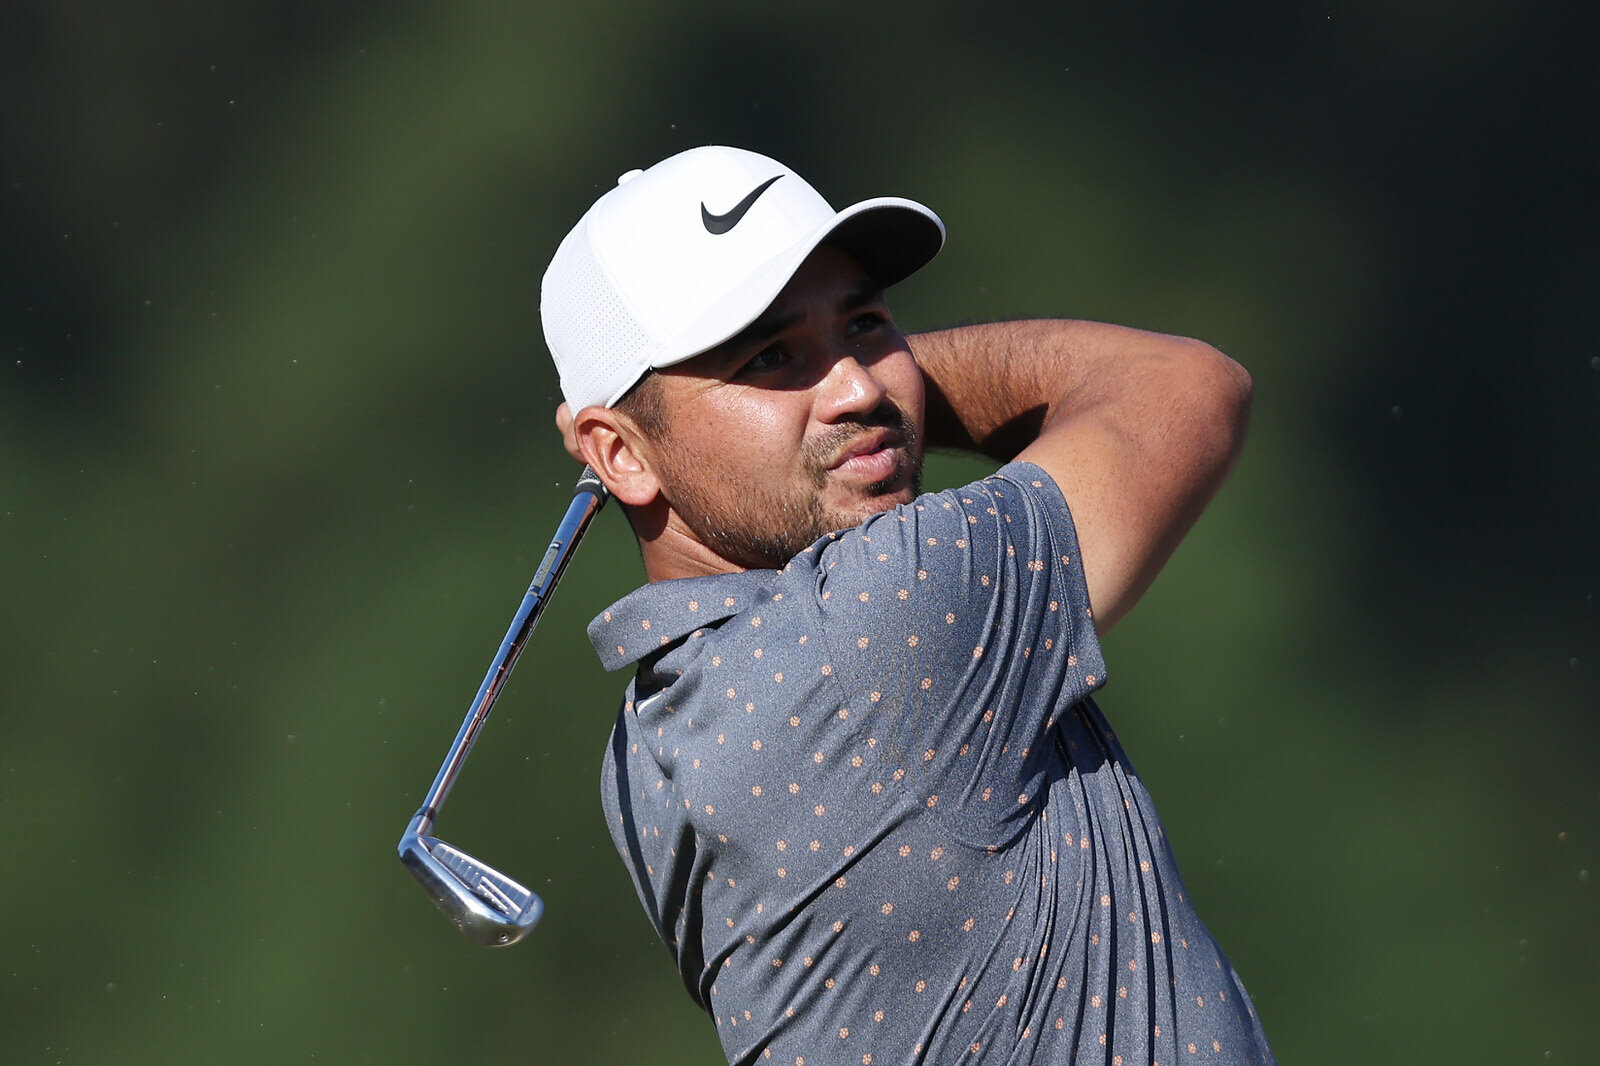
[[589, 570, 778, 671]]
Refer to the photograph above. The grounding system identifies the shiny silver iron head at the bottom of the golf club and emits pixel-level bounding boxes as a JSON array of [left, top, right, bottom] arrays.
[[400, 832, 544, 948]]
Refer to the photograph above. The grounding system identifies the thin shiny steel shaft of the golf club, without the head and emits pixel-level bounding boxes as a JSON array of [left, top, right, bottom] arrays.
[[411, 466, 610, 834]]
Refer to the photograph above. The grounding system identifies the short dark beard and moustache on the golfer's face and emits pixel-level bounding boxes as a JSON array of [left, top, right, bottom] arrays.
[[661, 408, 923, 570]]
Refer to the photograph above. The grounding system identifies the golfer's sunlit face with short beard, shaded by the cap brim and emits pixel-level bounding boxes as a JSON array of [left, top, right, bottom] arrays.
[[651, 246, 923, 568]]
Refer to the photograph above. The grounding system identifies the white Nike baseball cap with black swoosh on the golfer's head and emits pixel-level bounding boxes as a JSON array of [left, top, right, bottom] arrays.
[[539, 146, 944, 413]]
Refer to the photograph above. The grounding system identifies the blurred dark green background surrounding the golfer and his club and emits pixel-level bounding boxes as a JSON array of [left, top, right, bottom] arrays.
[[0, 0, 1600, 1066]]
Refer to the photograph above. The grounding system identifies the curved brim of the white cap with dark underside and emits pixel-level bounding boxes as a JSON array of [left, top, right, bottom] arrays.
[[633, 197, 944, 385]]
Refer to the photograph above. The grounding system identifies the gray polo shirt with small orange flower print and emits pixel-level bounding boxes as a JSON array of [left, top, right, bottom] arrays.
[[590, 464, 1274, 1066]]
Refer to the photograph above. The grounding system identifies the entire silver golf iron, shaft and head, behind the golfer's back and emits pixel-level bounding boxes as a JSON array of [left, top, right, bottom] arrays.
[[400, 466, 610, 948]]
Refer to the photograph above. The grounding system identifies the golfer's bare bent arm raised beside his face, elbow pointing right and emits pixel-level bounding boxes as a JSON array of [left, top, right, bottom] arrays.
[[910, 320, 1251, 634]]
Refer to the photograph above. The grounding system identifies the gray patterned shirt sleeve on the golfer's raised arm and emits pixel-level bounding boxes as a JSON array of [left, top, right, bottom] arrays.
[[818, 463, 1106, 847]]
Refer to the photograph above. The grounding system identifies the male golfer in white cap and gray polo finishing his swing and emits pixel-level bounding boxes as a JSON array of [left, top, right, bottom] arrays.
[[542, 147, 1272, 1066]]
